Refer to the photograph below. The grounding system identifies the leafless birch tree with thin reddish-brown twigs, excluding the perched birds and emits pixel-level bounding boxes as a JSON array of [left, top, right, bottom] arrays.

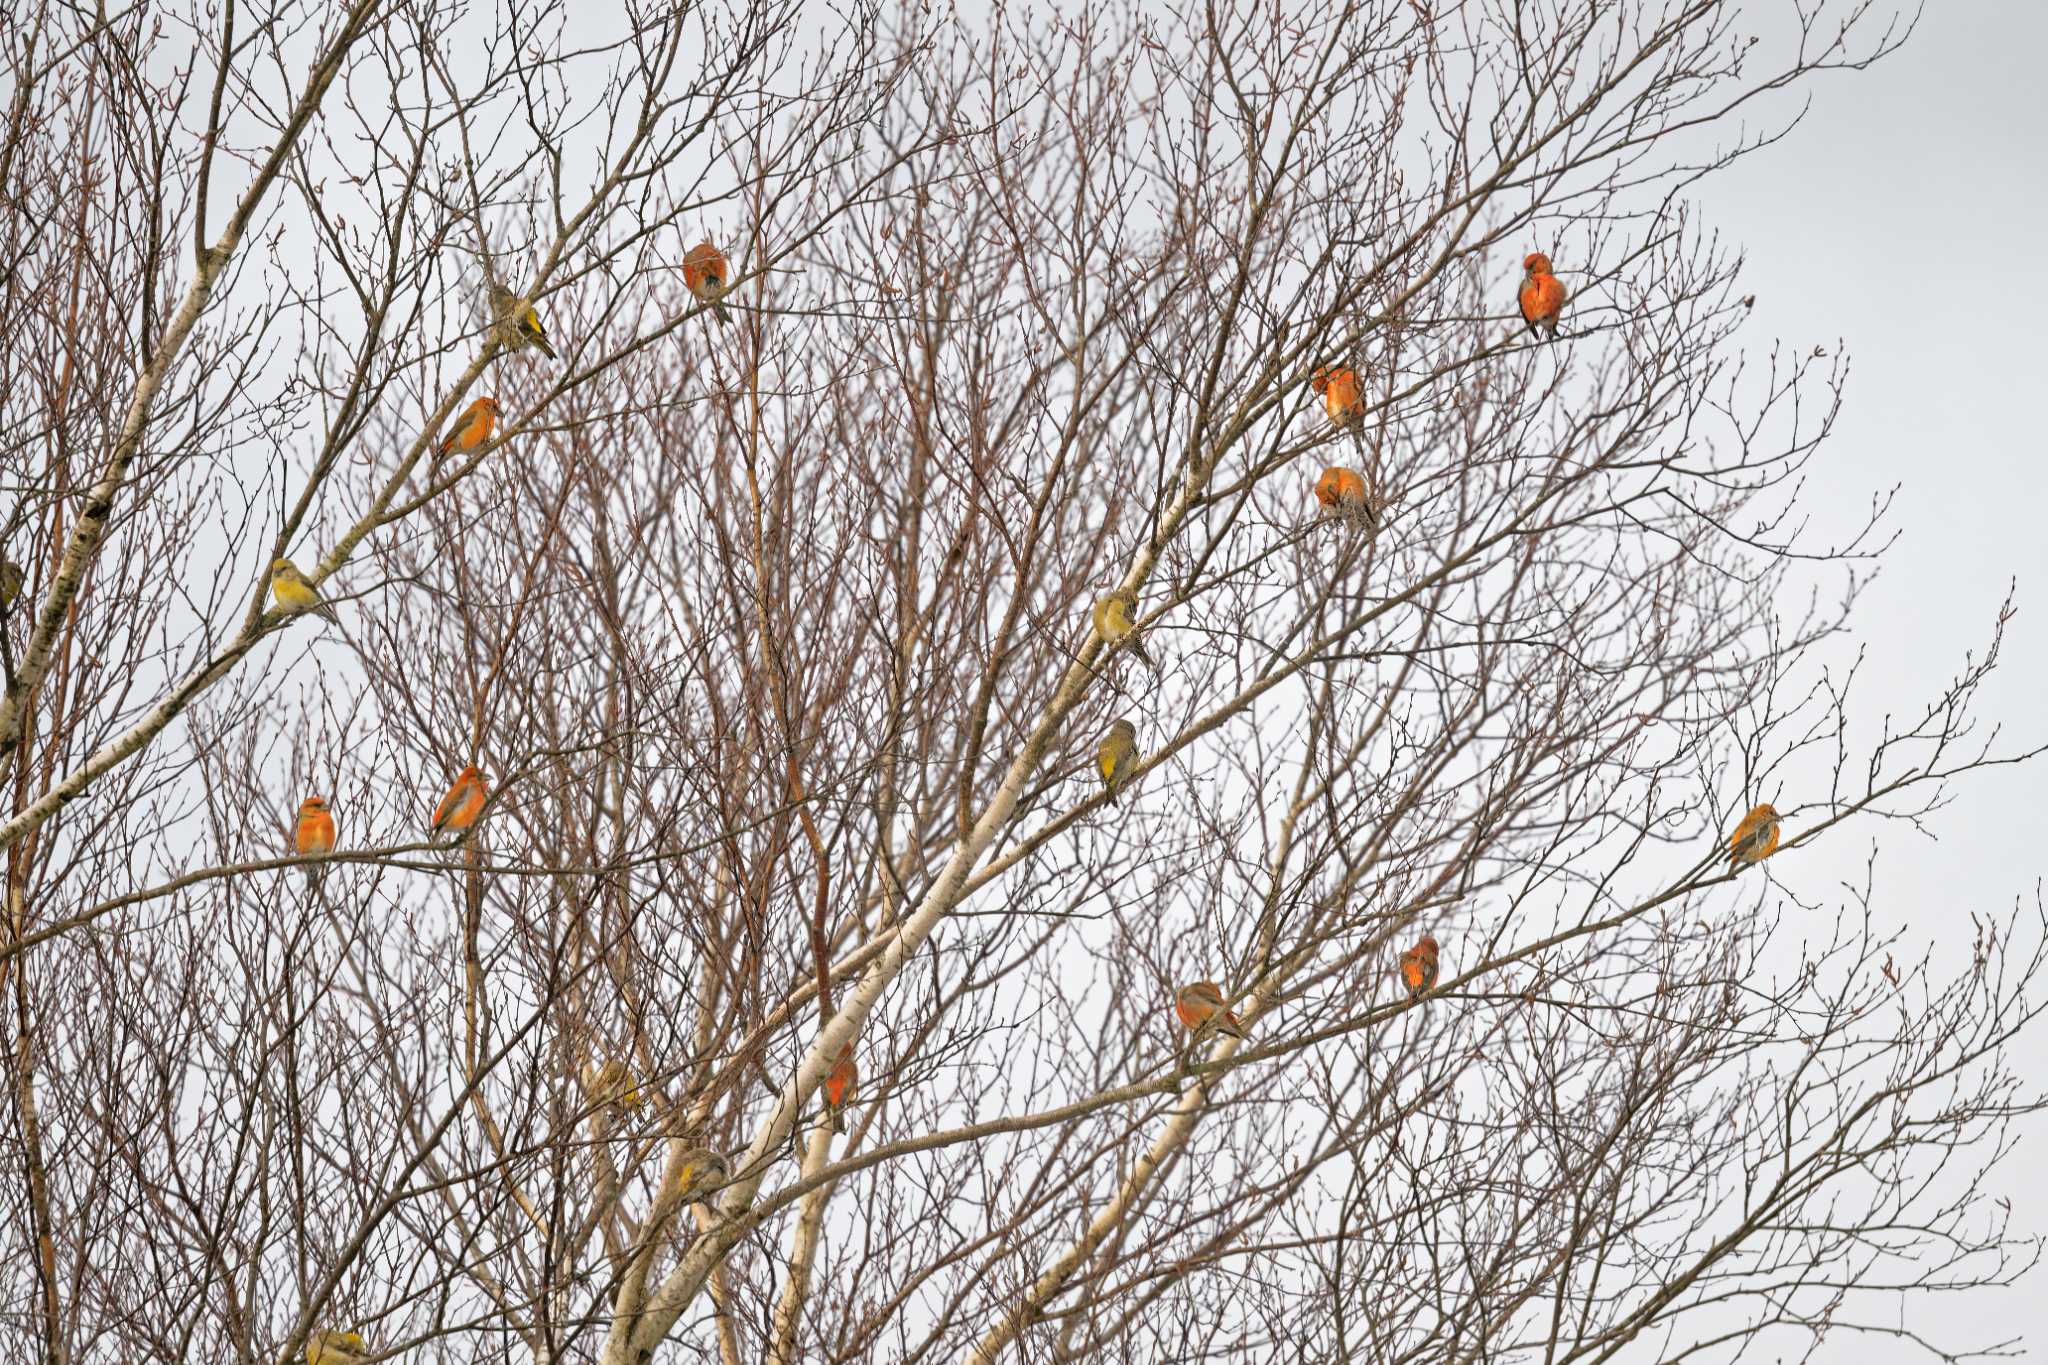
[[0, 0, 2044, 1365]]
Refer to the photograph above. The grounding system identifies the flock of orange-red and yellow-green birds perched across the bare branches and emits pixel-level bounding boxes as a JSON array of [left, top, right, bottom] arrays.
[[207, 241, 1780, 1365]]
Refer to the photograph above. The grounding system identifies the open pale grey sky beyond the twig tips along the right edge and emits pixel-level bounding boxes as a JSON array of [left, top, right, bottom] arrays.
[[1698, 0, 2048, 1361]]
